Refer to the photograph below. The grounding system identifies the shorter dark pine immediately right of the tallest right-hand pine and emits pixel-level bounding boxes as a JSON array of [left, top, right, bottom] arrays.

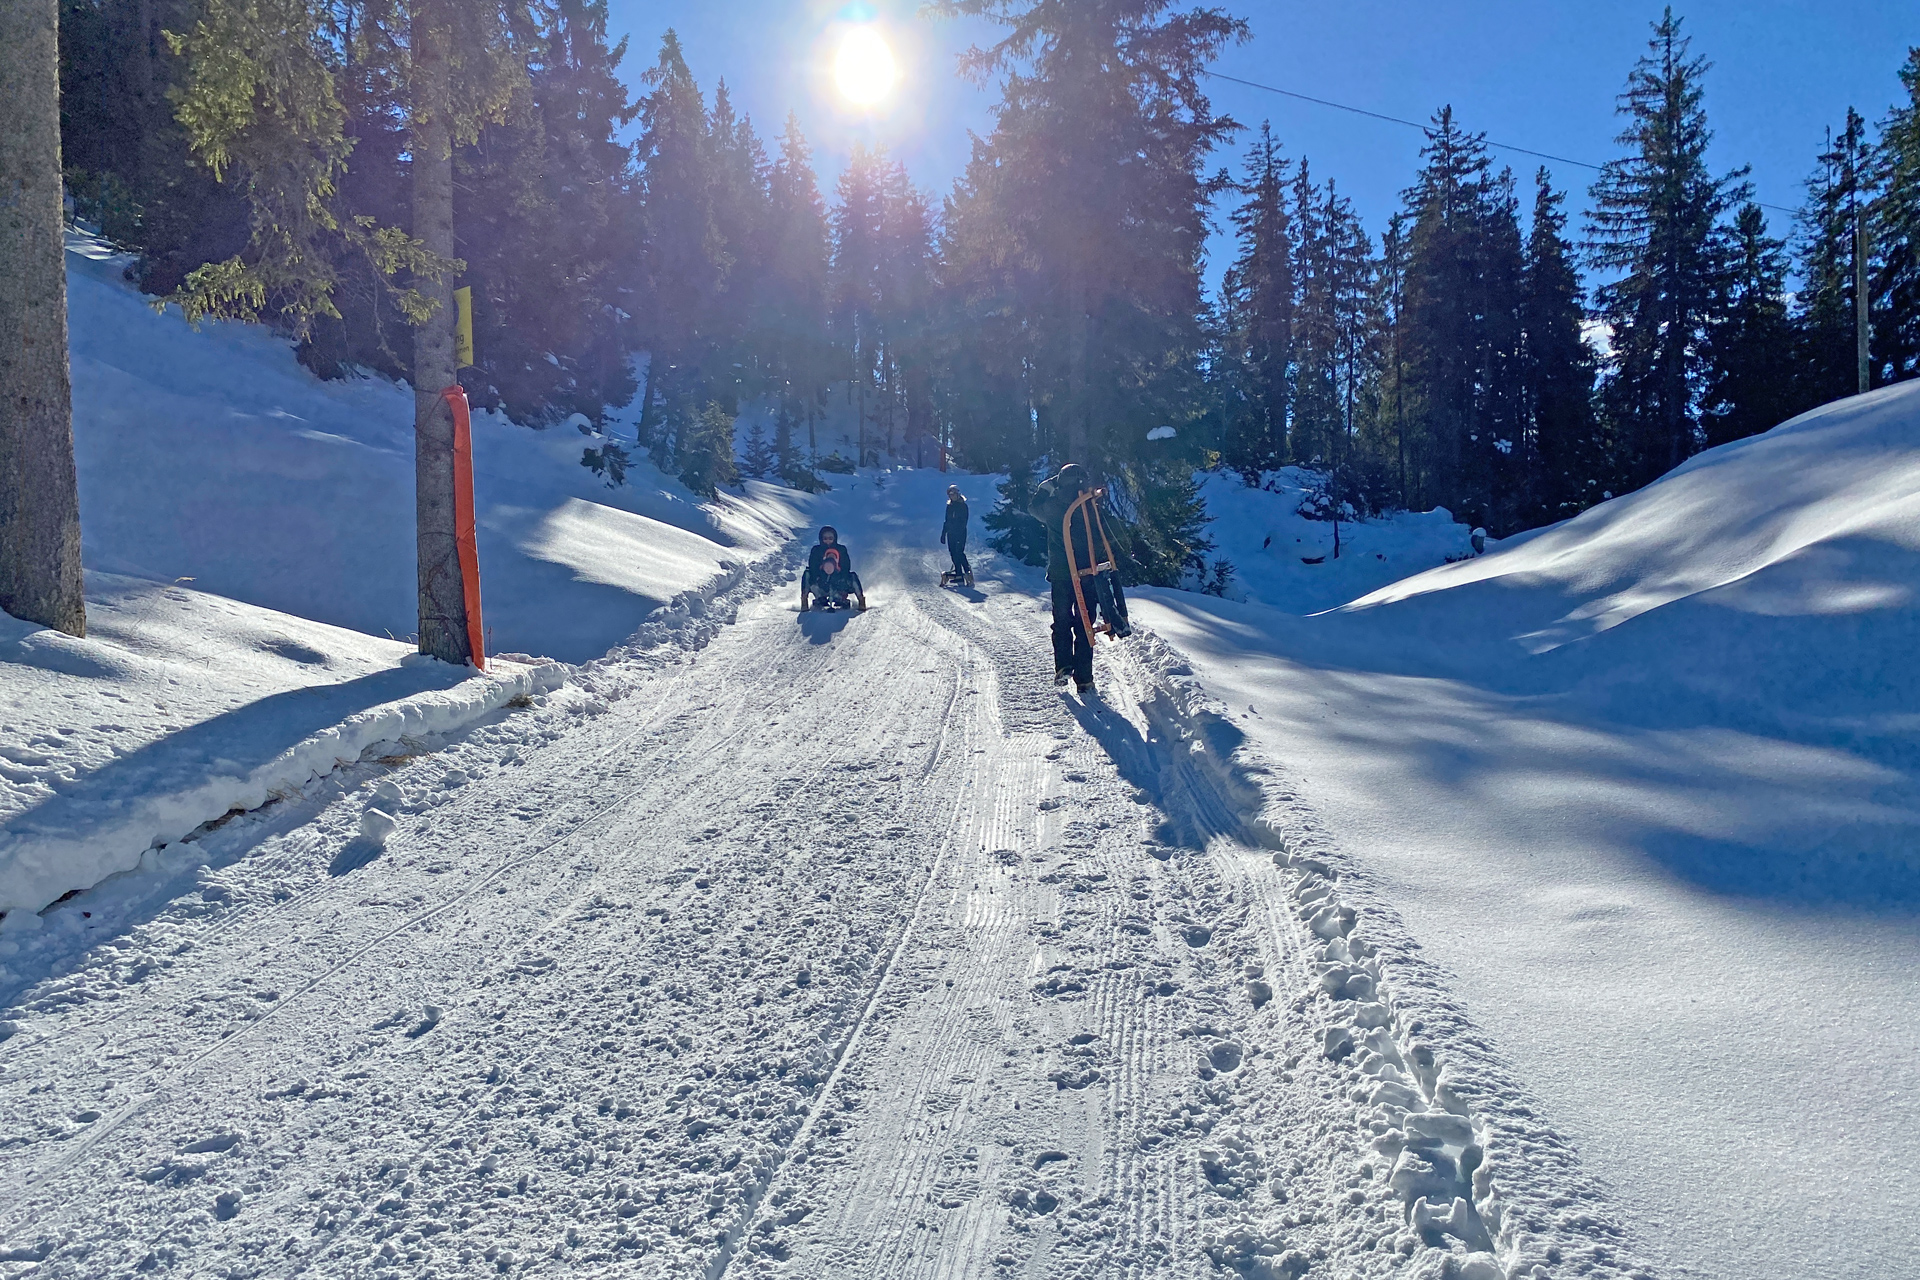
[[1703, 203, 1803, 447]]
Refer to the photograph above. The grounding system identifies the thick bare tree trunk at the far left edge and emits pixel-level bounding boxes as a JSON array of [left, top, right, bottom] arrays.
[[0, 0, 86, 635]]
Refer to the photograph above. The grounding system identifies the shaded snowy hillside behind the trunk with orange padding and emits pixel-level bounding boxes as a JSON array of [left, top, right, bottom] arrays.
[[67, 238, 808, 662]]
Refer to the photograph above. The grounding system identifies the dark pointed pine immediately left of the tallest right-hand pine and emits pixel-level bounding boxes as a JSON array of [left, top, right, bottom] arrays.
[[1517, 169, 1603, 528]]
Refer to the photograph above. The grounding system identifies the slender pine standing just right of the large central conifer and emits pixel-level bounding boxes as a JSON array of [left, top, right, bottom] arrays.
[[1221, 123, 1294, 477]]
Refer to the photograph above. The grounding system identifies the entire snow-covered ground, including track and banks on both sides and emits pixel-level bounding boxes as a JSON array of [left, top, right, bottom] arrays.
[[0, 233, 1920, 1280]]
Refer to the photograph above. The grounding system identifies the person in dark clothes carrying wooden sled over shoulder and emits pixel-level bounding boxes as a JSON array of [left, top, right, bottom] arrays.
[[1027, 462, 1133, 693]]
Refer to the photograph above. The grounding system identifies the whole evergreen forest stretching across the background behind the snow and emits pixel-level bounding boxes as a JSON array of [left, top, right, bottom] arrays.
[[60, 0, 1920, 583]]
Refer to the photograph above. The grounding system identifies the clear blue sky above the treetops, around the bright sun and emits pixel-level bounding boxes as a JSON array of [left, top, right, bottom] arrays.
[[611, 0, 1920, 264]]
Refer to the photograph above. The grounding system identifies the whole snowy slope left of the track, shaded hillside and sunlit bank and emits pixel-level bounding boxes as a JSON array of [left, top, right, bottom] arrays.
[[0, 236, 810, 931]]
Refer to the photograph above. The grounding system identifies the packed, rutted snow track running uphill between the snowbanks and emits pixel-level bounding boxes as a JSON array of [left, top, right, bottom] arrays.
[[0, 476, 1651, 1280]]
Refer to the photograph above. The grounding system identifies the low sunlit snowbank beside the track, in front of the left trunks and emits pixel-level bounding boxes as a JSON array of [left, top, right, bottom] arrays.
[[0, 574, 564, 931]]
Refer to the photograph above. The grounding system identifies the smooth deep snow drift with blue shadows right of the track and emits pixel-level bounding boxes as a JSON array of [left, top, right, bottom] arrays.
[[1139, 384, 1920, 1280]]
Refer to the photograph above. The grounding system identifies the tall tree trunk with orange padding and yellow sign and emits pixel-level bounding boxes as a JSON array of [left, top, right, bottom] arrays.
[[409, 10, 474, 664]]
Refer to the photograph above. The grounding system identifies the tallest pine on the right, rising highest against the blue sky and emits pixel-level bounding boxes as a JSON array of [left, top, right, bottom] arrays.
[[1588, 8, 1749, 491]]
